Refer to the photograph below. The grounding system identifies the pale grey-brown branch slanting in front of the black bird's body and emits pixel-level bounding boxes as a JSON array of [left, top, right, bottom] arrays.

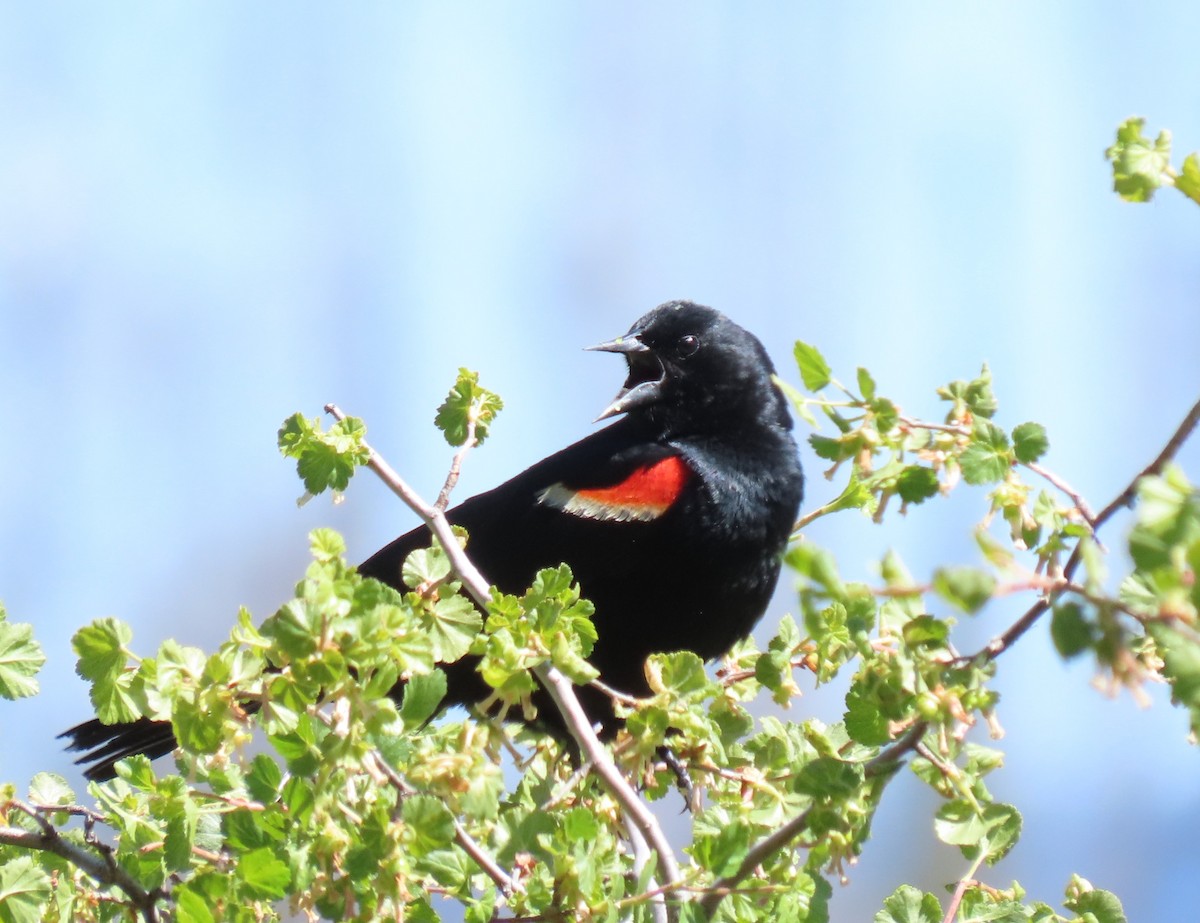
[[325, 403, 680, 915]]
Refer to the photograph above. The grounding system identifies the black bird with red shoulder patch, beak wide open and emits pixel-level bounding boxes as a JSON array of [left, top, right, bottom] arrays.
[[62, 301, 803, 779]]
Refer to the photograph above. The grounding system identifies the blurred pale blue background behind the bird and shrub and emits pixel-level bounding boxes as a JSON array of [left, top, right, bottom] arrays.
[[0, 0, 1200, 923]]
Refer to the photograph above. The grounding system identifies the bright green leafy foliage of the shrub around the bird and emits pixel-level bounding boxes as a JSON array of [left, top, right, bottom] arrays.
[[0, 120, 1200, 923]]
